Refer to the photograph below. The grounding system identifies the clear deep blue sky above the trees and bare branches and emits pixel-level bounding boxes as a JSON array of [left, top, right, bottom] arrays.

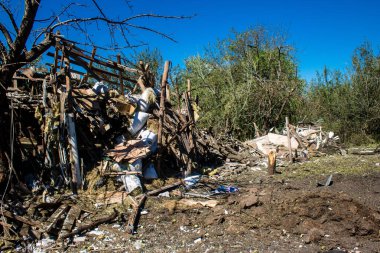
[[0, 0, 380, 80]]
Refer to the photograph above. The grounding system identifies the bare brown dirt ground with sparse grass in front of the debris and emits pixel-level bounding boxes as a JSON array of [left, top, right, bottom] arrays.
[[39, 155, 380, 252]]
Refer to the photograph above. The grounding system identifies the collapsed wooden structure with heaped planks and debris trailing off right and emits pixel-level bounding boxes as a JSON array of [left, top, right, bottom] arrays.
[[1, 36, 344, 250]]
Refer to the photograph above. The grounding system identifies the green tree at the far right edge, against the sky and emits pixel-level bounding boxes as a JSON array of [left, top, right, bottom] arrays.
[[300, 42, 380, 144]]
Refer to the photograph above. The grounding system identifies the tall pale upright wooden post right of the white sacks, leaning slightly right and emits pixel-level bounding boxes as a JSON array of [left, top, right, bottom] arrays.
[[157, 61, 170, 175]]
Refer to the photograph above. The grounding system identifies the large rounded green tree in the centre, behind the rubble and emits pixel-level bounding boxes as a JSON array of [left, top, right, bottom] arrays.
[[185, 27, 304, 138]]
